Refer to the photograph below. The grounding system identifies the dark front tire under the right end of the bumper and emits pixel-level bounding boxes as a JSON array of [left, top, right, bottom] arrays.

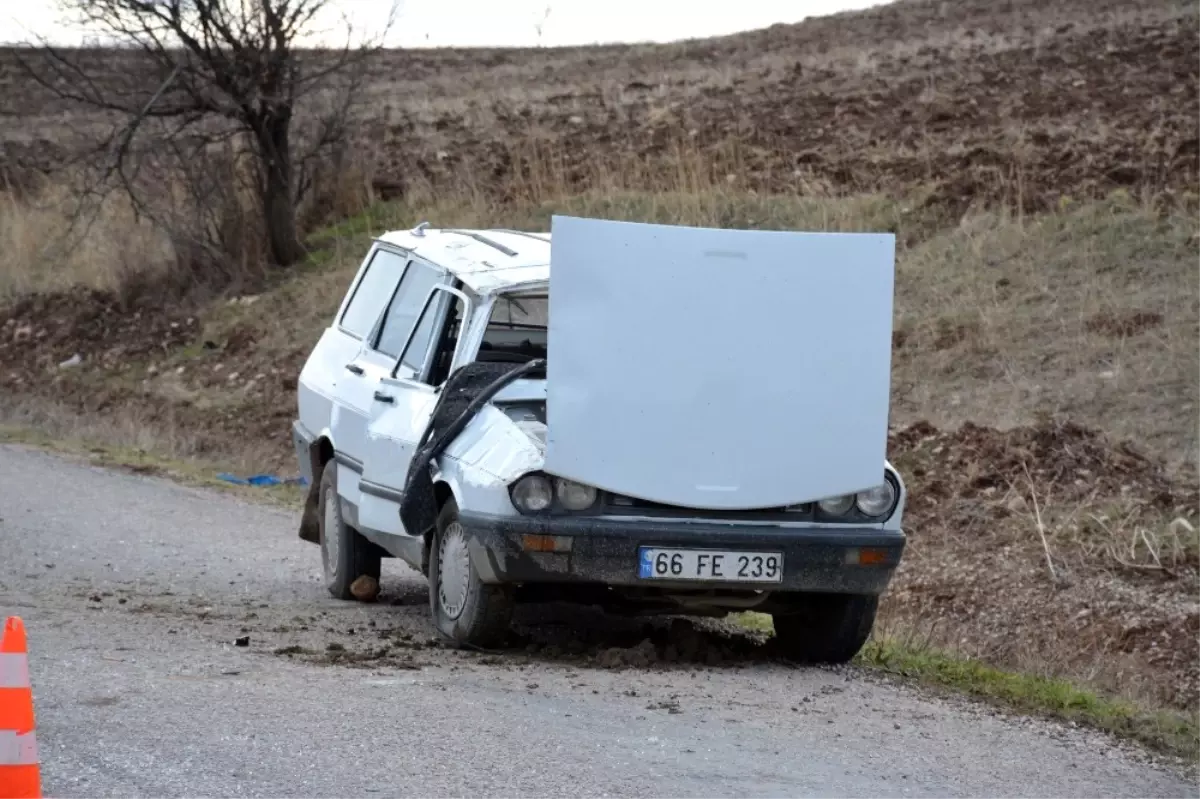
[[773, 594, 880, 663]]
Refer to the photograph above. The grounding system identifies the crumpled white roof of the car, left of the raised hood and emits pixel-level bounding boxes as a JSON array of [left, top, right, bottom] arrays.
[[377, 223, 550, 294]]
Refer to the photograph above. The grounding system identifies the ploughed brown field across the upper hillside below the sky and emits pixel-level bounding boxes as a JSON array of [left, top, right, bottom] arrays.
[[0, 0, 1200, 209]]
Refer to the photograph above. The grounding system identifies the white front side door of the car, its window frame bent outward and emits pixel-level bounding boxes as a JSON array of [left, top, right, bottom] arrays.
[[359, 279, 472, 535]]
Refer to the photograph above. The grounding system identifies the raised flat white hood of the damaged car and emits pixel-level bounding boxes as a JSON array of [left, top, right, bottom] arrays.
[[545, 216, 895, 509]]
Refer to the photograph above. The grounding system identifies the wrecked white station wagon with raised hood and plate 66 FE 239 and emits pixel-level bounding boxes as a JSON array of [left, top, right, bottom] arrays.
[[293, 217, 906, 662]]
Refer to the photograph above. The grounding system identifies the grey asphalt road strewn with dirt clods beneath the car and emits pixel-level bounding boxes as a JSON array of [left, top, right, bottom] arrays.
[[0, 447, 1200, 799]]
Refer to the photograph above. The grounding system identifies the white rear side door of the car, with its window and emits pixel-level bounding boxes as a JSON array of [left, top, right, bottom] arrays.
[[330, 246, 409, 489]]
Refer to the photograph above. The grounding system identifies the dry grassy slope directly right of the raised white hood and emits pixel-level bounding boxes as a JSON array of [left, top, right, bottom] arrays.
[[894, 196, 1200, 462]]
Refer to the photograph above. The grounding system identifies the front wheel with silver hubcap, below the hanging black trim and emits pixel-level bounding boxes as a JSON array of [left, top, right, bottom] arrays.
[[428, 498, 514, 648]]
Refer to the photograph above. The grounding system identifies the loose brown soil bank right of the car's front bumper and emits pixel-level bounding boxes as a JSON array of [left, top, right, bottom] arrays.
[[888, 422, 1200, 707]]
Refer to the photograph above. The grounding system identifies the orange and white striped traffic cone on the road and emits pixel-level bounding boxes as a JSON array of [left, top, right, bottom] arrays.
[[0, 615, 42, 799]]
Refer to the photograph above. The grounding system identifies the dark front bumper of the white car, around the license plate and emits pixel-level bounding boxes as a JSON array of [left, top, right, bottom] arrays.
[[458, 512, 906, 594]]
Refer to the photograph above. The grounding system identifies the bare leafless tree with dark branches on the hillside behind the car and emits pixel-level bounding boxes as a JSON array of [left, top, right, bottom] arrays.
[[24, 0, 396, 266]]
